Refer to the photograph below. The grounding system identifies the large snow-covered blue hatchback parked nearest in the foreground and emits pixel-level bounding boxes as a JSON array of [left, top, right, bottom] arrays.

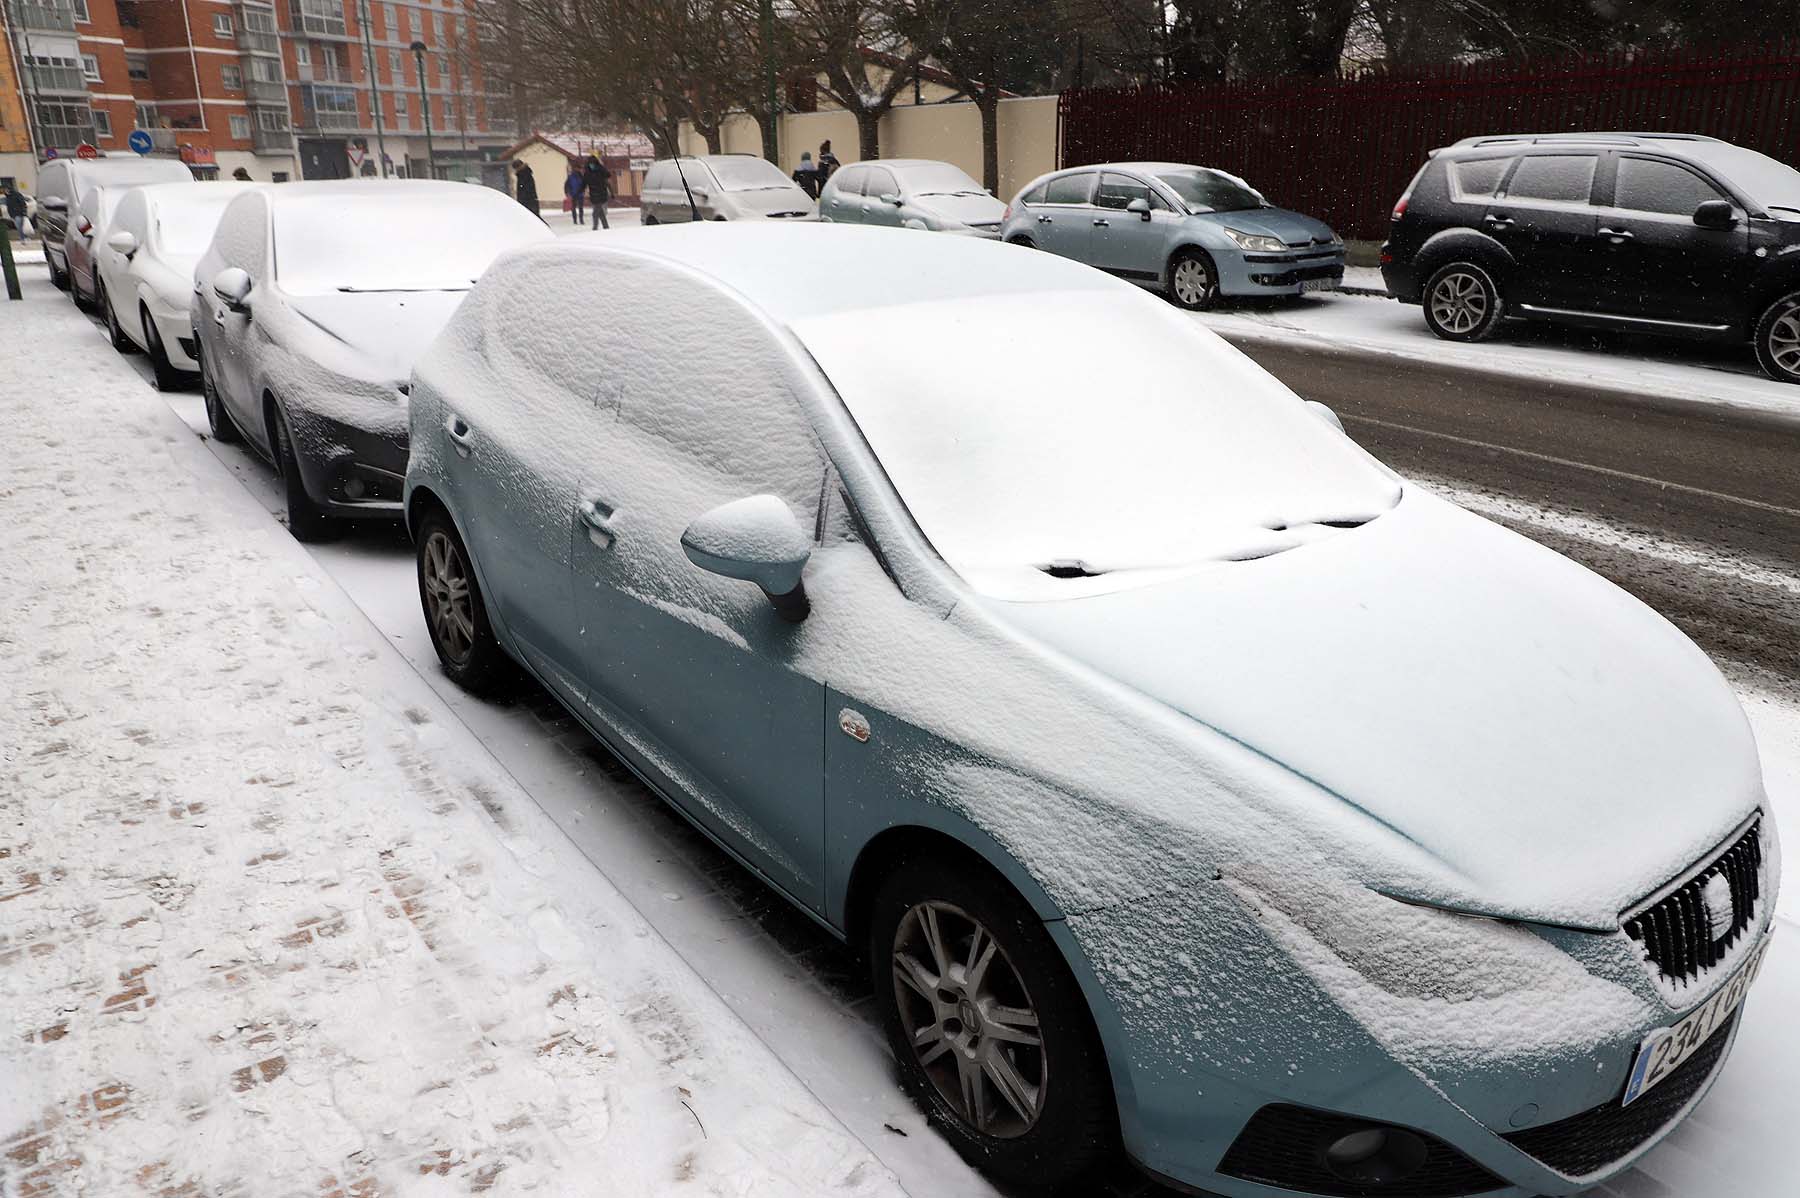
[[405, 225, 1778, 1198]]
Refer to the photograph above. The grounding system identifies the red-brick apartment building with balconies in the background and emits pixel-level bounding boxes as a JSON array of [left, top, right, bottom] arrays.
[[0, 0, 515, 187]]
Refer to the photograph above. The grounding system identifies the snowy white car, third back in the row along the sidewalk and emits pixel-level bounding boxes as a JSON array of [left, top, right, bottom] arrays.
[[95, 183, 256, 390]]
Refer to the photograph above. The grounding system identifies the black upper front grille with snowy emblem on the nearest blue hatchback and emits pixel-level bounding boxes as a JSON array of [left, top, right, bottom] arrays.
[[1624, 817, 1762, 989]]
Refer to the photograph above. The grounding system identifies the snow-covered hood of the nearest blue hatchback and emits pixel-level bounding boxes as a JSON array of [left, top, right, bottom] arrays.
[[986, 487, 1762, 930]]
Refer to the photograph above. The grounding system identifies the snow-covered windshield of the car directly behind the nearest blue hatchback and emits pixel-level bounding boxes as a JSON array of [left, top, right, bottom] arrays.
[[274, 185, 553, 295]]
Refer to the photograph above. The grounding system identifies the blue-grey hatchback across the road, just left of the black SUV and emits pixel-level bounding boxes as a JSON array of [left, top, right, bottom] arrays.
[[1001, 162, 1345, 309]]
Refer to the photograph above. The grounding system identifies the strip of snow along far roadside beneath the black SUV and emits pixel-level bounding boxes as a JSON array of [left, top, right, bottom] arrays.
[[1195, 287, 1800, 419]]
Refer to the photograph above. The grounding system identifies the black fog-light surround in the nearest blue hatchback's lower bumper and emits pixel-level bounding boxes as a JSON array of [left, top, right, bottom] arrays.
[[1219, 1108, 1504, 1198]]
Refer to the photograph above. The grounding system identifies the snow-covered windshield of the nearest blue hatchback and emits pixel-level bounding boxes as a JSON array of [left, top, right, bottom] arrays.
[[790, 286, 1399, 594]]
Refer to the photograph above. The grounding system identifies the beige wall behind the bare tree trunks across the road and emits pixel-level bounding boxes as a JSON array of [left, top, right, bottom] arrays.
[[680, 95, 1057, 200]]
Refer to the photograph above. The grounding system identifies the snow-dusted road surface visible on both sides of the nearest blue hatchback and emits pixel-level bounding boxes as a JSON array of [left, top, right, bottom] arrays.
[[28, 268, 1800, 1198]]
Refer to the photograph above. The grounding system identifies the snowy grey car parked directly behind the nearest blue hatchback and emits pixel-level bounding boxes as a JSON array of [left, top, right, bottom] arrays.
[[189, 180, 554, 540]]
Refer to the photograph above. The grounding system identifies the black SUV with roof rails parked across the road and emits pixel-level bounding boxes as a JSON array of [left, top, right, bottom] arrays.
[[1381, 133, 1800, 383]]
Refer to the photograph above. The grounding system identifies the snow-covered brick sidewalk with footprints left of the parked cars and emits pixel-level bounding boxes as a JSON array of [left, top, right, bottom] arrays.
[[0, 275, 898, 1198]]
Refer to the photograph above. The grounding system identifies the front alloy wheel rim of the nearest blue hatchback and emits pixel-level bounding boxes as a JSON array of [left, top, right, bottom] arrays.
[[893, 901, 1049, 1139]]
